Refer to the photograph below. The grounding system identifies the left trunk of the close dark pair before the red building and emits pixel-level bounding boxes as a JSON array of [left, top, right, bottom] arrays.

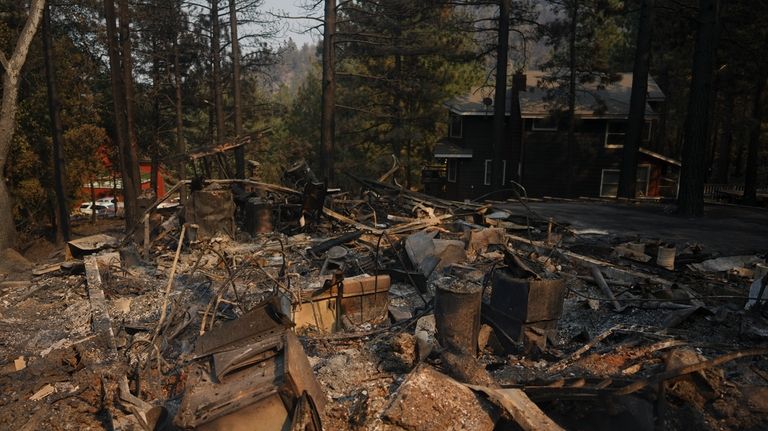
[[104, 0, 140, 231]]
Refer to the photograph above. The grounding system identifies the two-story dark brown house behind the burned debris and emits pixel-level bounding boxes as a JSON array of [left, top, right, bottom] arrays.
[[422, 71, 680, 199]]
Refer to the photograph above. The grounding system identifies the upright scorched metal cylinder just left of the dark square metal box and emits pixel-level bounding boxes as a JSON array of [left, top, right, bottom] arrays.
[[435, 280, 483, 355]]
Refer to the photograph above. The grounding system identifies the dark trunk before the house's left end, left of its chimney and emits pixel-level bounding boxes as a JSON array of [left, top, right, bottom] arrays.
[[491, 0, 509, 188]]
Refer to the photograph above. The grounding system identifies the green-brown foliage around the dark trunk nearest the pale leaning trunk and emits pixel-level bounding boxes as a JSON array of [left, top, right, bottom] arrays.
[[0, 2, 106, 236]]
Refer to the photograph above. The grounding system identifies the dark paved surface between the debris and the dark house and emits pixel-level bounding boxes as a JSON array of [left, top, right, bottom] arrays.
[[500, 201, 768, 256]]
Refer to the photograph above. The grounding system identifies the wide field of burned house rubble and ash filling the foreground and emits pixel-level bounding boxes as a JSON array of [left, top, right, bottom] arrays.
[[0, 162, 768, 431]]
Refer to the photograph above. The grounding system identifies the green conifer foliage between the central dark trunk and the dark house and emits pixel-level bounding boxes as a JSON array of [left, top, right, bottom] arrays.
[[337, 0, 477, 186]]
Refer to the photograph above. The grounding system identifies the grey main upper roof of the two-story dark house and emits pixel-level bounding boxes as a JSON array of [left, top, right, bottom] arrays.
[[447, 71, 664, 118]]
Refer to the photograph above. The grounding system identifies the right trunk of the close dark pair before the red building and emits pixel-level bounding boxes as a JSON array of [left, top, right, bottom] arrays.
[[118, 0, 141, 201]]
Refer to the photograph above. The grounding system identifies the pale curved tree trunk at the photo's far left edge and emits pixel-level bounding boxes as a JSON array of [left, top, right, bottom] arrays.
[[0, 0, 45, 250]]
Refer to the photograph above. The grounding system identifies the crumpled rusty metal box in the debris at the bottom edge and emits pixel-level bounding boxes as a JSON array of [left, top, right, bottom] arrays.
[[175, 290, 325, 431]]
